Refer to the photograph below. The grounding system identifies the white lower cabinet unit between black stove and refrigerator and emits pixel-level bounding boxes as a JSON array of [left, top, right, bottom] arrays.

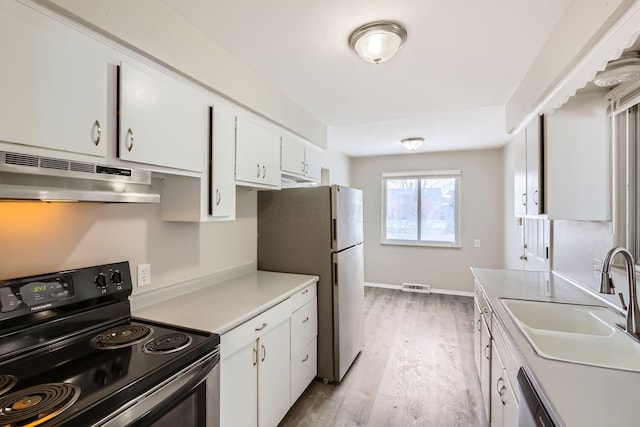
[[220, 283, 318, 427]]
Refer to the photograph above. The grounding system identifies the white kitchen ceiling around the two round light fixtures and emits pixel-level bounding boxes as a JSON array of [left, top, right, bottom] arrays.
[[165, 0, 569, 157]]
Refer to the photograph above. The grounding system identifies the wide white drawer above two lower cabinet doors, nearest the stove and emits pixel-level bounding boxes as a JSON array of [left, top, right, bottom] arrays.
[[220, 298, 291, 359]]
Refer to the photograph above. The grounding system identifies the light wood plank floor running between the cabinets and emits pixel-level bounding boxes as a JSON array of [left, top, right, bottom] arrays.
[[280, 288, 487, 427]]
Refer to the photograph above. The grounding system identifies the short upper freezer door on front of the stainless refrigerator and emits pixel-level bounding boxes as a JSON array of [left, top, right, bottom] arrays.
[[331, 185, 362, 252]]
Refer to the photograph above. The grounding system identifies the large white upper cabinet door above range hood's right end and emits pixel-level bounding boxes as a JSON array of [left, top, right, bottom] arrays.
[[118, 63, 209, 172]]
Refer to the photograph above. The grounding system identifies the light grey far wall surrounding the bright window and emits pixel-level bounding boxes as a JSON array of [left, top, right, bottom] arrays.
[[351, 149, 503, 291]]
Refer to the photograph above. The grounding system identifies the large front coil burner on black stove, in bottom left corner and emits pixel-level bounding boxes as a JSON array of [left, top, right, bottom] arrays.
[[0, 383, 80, 427]]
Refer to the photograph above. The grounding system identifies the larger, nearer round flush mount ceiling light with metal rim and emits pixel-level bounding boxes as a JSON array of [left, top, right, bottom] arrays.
[[349, 21, 407, 64]]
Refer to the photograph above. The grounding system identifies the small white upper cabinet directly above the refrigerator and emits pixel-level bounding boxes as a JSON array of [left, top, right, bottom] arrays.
[[281, 137, 321, 182]]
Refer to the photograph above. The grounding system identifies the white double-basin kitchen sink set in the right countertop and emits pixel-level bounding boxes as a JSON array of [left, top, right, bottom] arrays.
[[500, 299, 640, 371]]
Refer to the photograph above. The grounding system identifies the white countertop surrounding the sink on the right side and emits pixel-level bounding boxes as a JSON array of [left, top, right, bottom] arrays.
[[472, 268, 640, 427]]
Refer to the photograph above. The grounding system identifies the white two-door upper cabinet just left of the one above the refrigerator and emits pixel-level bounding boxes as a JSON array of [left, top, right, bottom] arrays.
[[236, 116, 281, 188]]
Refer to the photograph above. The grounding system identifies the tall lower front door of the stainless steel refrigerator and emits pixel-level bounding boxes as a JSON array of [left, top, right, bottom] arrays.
[[333, 244, 364, 381]]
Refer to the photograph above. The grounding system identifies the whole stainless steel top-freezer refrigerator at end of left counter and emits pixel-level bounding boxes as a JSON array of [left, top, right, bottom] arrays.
[[258, 185, 364, 382]]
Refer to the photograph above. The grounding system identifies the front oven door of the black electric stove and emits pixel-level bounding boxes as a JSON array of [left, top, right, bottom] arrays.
[[94, 350, 220, 427]]
